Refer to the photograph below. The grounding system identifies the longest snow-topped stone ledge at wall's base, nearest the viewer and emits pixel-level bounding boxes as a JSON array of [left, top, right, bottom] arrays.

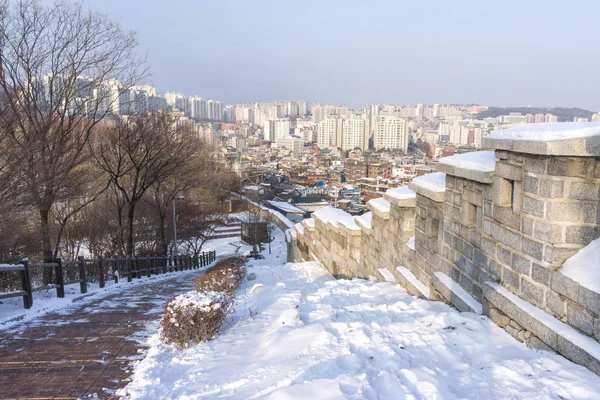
[[483, 282, 600, 375]]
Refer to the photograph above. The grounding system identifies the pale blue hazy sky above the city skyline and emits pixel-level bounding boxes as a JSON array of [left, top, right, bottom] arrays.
[[87, 0, 600, 111]]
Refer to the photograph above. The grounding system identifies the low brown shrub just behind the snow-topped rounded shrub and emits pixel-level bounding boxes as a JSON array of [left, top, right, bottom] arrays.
[[192, 257, 246, 296]]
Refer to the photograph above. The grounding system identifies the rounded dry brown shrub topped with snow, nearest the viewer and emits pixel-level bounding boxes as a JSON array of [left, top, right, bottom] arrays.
[[161, 291, 231, 349]]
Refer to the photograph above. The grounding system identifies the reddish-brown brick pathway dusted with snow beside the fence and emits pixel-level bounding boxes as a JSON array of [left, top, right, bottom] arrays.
[[0, 270, 202, 399]]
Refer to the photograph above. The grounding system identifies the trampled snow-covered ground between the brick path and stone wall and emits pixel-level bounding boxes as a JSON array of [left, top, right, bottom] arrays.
[[121, 234, 600, 400]]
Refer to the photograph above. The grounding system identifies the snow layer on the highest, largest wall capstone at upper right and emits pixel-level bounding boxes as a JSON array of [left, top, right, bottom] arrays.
[[488, 122, 600, 142]]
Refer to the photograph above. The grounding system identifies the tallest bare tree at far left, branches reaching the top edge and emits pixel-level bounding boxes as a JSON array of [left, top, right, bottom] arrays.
[[0, 0, 144, 270]]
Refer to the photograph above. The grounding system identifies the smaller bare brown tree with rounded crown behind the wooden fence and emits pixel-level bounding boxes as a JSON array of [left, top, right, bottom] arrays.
[[92, 111, 193, 256]]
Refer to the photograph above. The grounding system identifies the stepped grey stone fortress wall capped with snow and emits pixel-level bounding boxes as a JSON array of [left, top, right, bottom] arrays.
[[290, 123, 600, 374]]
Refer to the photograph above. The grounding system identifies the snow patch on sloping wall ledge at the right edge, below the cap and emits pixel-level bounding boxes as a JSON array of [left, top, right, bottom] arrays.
[[560, 238, 600, 293]]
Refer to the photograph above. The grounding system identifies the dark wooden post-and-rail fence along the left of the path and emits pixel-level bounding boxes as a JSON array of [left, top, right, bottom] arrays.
[[0, 251, 216, 308]]
